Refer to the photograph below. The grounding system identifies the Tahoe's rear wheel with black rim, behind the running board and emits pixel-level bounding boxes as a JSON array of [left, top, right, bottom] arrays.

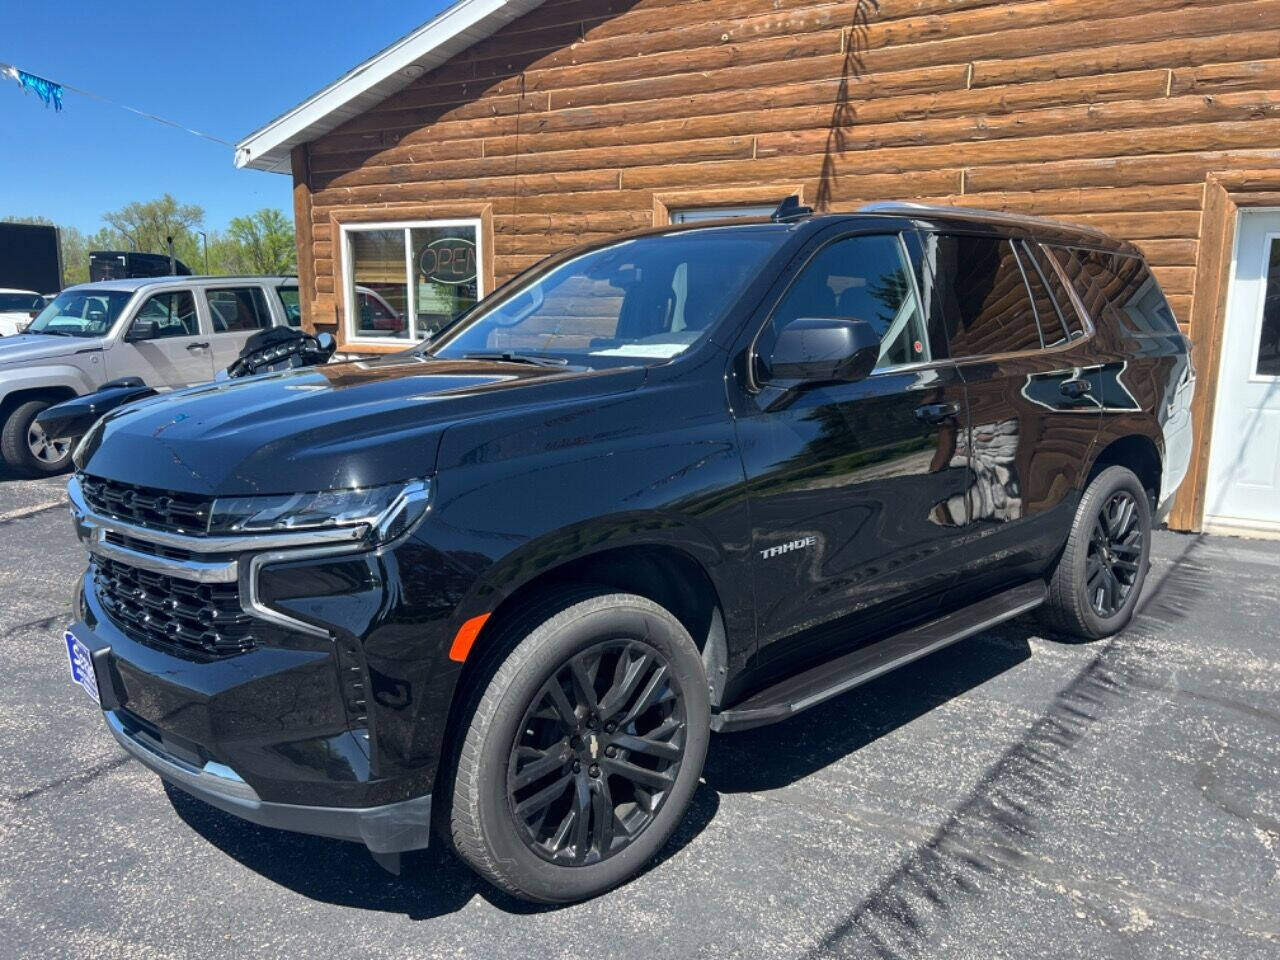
[[1042, 466, 1151, 640]]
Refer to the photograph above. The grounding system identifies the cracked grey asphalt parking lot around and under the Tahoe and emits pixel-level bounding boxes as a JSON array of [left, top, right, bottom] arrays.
[[0, 481, 1280, 960]]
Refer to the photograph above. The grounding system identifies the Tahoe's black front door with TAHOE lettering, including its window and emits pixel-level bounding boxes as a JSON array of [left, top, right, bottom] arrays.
[[736, 233, 968, 660]]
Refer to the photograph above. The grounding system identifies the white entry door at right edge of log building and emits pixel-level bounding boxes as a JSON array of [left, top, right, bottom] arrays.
[[1204, 210, 1280, 531]]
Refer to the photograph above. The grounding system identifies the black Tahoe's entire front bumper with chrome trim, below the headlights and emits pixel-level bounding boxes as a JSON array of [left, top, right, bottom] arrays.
[[69, 481, 470, 854]]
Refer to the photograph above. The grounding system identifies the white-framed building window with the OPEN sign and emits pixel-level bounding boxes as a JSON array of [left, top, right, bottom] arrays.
[[342, 220, 485, 343]]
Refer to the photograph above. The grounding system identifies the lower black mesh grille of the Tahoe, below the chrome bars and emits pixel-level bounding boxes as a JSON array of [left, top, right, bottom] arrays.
[[93, 557, 253, 657]]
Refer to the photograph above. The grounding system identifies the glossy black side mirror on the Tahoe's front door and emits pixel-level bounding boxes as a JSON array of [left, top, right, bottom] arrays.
[[765, 317, 881, 387]]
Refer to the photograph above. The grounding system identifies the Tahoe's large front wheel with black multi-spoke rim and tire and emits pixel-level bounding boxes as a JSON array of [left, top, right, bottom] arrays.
[[448, 589, 710, 904]]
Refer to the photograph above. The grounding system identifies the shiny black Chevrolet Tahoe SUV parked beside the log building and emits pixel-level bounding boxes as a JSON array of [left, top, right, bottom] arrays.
[[65, 205, 1194, 901]]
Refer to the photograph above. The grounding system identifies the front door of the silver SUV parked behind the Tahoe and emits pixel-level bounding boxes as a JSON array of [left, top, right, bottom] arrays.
[[106, 289, 214, 387]]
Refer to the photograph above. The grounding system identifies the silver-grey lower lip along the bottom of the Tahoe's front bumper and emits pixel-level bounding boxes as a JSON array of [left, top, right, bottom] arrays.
[[104, 710, 431, 854]]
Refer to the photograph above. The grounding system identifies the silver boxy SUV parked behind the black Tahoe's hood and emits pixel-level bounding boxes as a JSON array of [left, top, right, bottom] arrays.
[[0, 276, 297, 476]]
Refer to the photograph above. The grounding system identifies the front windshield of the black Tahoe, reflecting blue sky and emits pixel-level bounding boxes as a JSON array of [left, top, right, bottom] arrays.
[[428, 224, 786, 366]]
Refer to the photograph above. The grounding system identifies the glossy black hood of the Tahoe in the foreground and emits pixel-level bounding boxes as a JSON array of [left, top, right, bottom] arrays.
[[77, 355, 645, 495]]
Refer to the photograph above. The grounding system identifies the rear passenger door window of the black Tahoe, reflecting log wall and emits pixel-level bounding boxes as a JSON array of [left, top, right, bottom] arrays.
[[933, 234, 1042, 358]]
